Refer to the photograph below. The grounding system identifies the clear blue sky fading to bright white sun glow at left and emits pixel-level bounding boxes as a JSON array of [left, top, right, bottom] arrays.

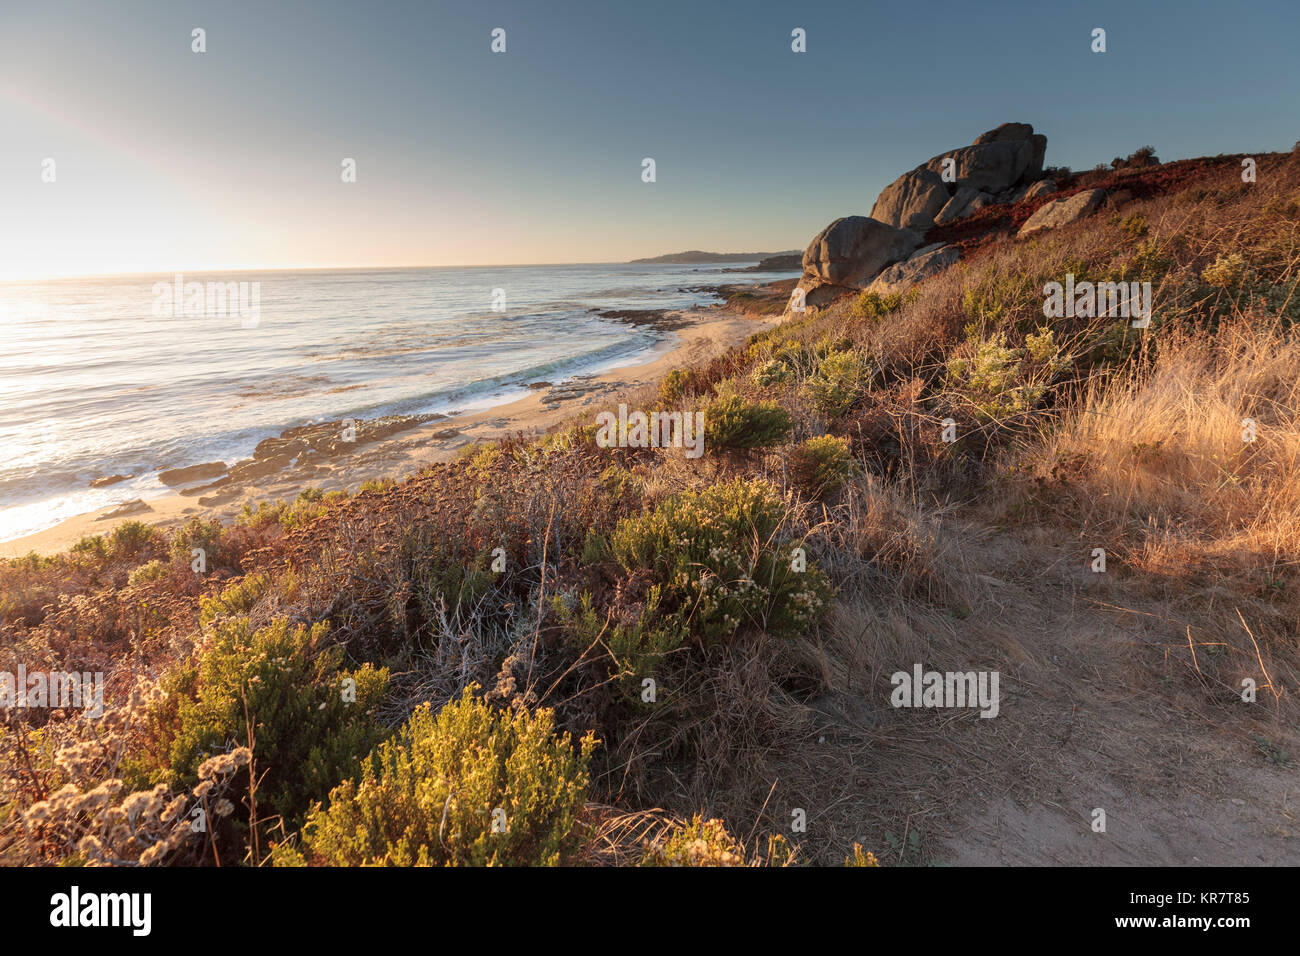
[[0, 0, 1300, 280]]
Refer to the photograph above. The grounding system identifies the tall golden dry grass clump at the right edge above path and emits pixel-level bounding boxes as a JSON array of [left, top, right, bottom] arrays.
[[1023, 316, 1300, 567]]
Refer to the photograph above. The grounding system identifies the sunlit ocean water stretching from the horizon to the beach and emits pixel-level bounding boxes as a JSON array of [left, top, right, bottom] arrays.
[[0, 263, 790, 541]]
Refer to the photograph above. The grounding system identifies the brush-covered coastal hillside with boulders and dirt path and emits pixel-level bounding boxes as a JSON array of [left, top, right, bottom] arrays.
[[0, 124, 1300, 866]]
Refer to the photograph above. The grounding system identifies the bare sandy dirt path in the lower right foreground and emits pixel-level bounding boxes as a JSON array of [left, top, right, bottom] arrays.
[[771, 522, 1300, 866]]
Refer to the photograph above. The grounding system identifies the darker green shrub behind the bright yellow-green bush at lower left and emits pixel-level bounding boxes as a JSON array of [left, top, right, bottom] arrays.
[[163, 619, 389, 821]]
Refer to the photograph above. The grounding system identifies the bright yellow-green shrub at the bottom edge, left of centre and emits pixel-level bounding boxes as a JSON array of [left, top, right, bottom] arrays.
[[295, 688, 595, 866]]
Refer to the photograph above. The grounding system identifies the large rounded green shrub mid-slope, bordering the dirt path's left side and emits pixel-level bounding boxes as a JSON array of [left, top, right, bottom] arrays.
[[610, 480, 829, 640]]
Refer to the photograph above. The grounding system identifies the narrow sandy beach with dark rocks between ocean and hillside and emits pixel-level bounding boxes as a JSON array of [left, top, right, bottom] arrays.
[[0, 304, 780, 558]]
